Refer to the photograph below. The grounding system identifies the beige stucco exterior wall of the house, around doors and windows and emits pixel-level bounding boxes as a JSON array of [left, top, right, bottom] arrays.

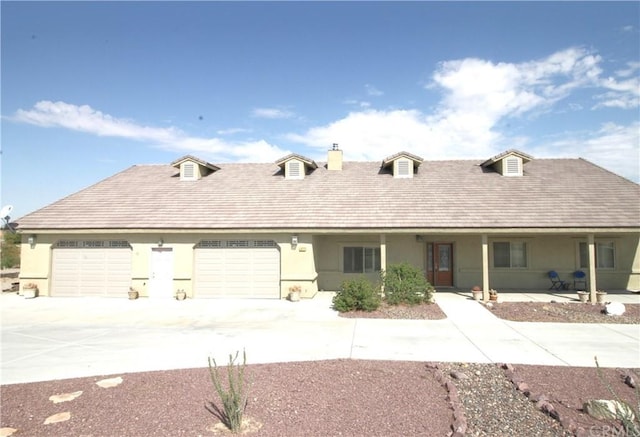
[[20, 228, 640, 298]]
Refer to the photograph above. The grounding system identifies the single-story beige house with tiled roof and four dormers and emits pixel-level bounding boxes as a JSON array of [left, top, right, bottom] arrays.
[[17, 147, 640, 299]]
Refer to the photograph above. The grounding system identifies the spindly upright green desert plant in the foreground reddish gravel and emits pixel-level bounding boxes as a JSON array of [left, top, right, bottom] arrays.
[[209, 352, 248, 433]]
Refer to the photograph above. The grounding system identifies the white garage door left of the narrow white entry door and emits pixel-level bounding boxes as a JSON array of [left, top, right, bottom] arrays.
[[51, 241, 131, 298]]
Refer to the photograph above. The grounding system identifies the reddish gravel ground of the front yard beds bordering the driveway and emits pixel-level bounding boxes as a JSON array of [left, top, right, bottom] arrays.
[[0, 303, 640, 437]]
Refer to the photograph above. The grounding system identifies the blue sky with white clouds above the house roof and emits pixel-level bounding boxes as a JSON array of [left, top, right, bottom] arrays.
[[1, 1, 640, 218]]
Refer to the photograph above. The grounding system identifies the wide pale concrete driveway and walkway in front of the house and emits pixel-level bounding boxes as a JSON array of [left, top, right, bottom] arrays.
[[0, 292, 640, 384]]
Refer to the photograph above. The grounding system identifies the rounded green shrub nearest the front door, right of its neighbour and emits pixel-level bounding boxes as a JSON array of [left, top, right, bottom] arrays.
[[381, 263, 433, 305]]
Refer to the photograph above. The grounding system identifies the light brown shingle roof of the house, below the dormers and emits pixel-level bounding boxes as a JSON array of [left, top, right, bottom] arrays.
[[18, 159, 640, 230]]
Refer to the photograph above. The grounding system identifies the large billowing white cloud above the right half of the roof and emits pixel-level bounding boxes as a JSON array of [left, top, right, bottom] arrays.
[[287, 48, 638, 175]]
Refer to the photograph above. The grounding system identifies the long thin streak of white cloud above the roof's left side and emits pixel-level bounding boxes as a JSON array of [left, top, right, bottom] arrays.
[[12, 101, 289, 161]]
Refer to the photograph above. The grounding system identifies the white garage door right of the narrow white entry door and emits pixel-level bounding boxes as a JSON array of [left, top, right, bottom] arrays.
[[194, 240, 280, 299]]
